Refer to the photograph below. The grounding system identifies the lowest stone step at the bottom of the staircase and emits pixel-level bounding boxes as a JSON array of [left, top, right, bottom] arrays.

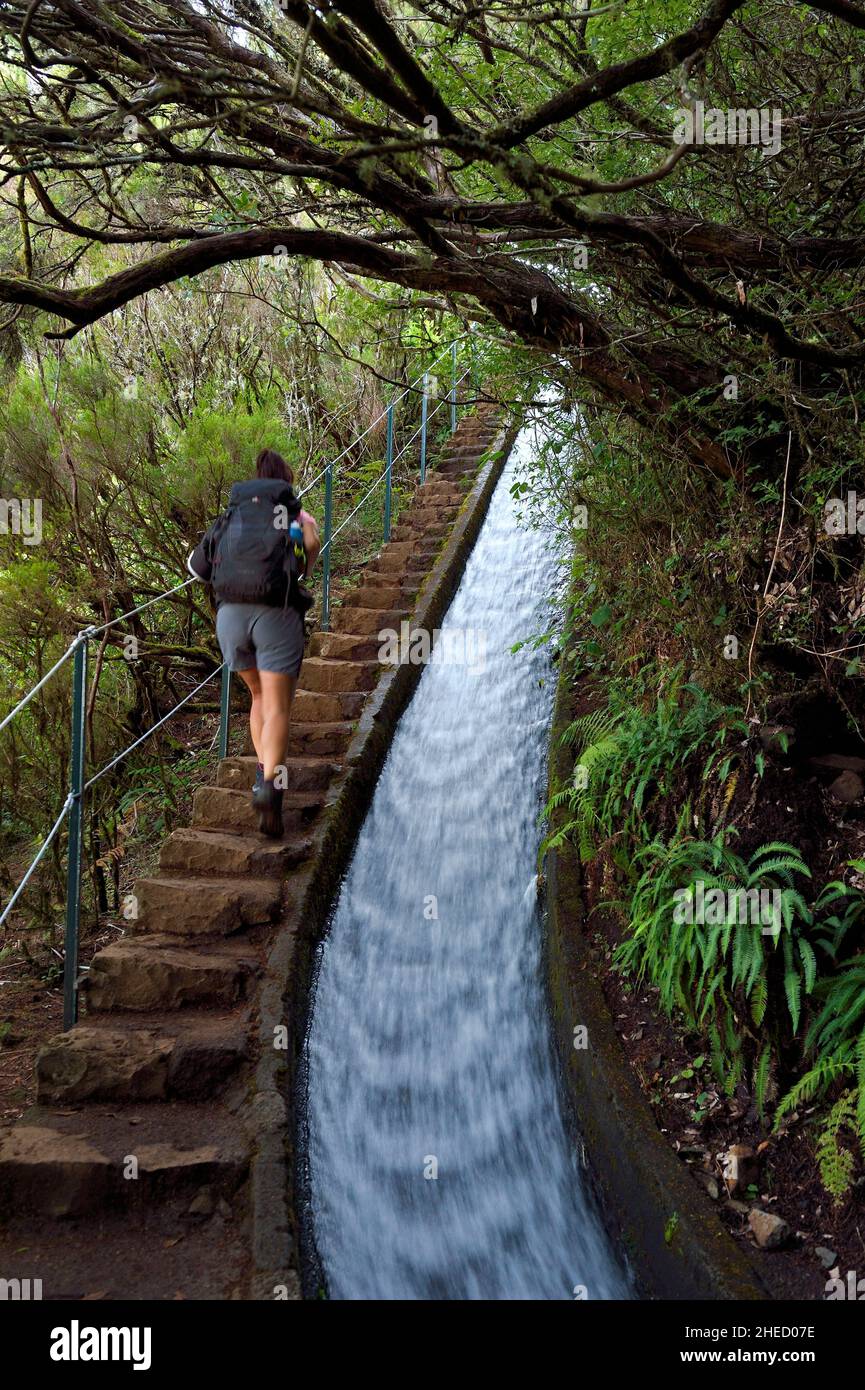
[[0, 1102, 249, 1219]]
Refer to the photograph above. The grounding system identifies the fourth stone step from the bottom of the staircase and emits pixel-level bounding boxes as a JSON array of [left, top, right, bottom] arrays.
[[129, 872, 282, 937]]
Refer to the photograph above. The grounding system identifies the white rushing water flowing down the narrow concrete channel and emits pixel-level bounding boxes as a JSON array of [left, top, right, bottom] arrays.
[[306, 431, 630, 1300]]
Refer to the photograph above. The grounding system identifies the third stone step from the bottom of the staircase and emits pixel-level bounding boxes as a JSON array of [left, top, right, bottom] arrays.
[[82, 937, 259, 1013]]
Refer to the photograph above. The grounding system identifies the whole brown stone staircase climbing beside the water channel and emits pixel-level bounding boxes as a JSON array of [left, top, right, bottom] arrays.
[[0, 407, 499, 1298]]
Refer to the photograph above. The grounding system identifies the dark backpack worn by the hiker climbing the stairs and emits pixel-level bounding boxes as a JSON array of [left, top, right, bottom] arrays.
[[210, 478, 303, 607]]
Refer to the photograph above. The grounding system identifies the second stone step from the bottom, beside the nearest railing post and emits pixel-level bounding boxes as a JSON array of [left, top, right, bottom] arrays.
[[36, 1015, 248, 1105]]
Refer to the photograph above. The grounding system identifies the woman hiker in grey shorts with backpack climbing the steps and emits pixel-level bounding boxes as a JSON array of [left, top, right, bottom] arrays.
[[186, 449, 321, 840]]
